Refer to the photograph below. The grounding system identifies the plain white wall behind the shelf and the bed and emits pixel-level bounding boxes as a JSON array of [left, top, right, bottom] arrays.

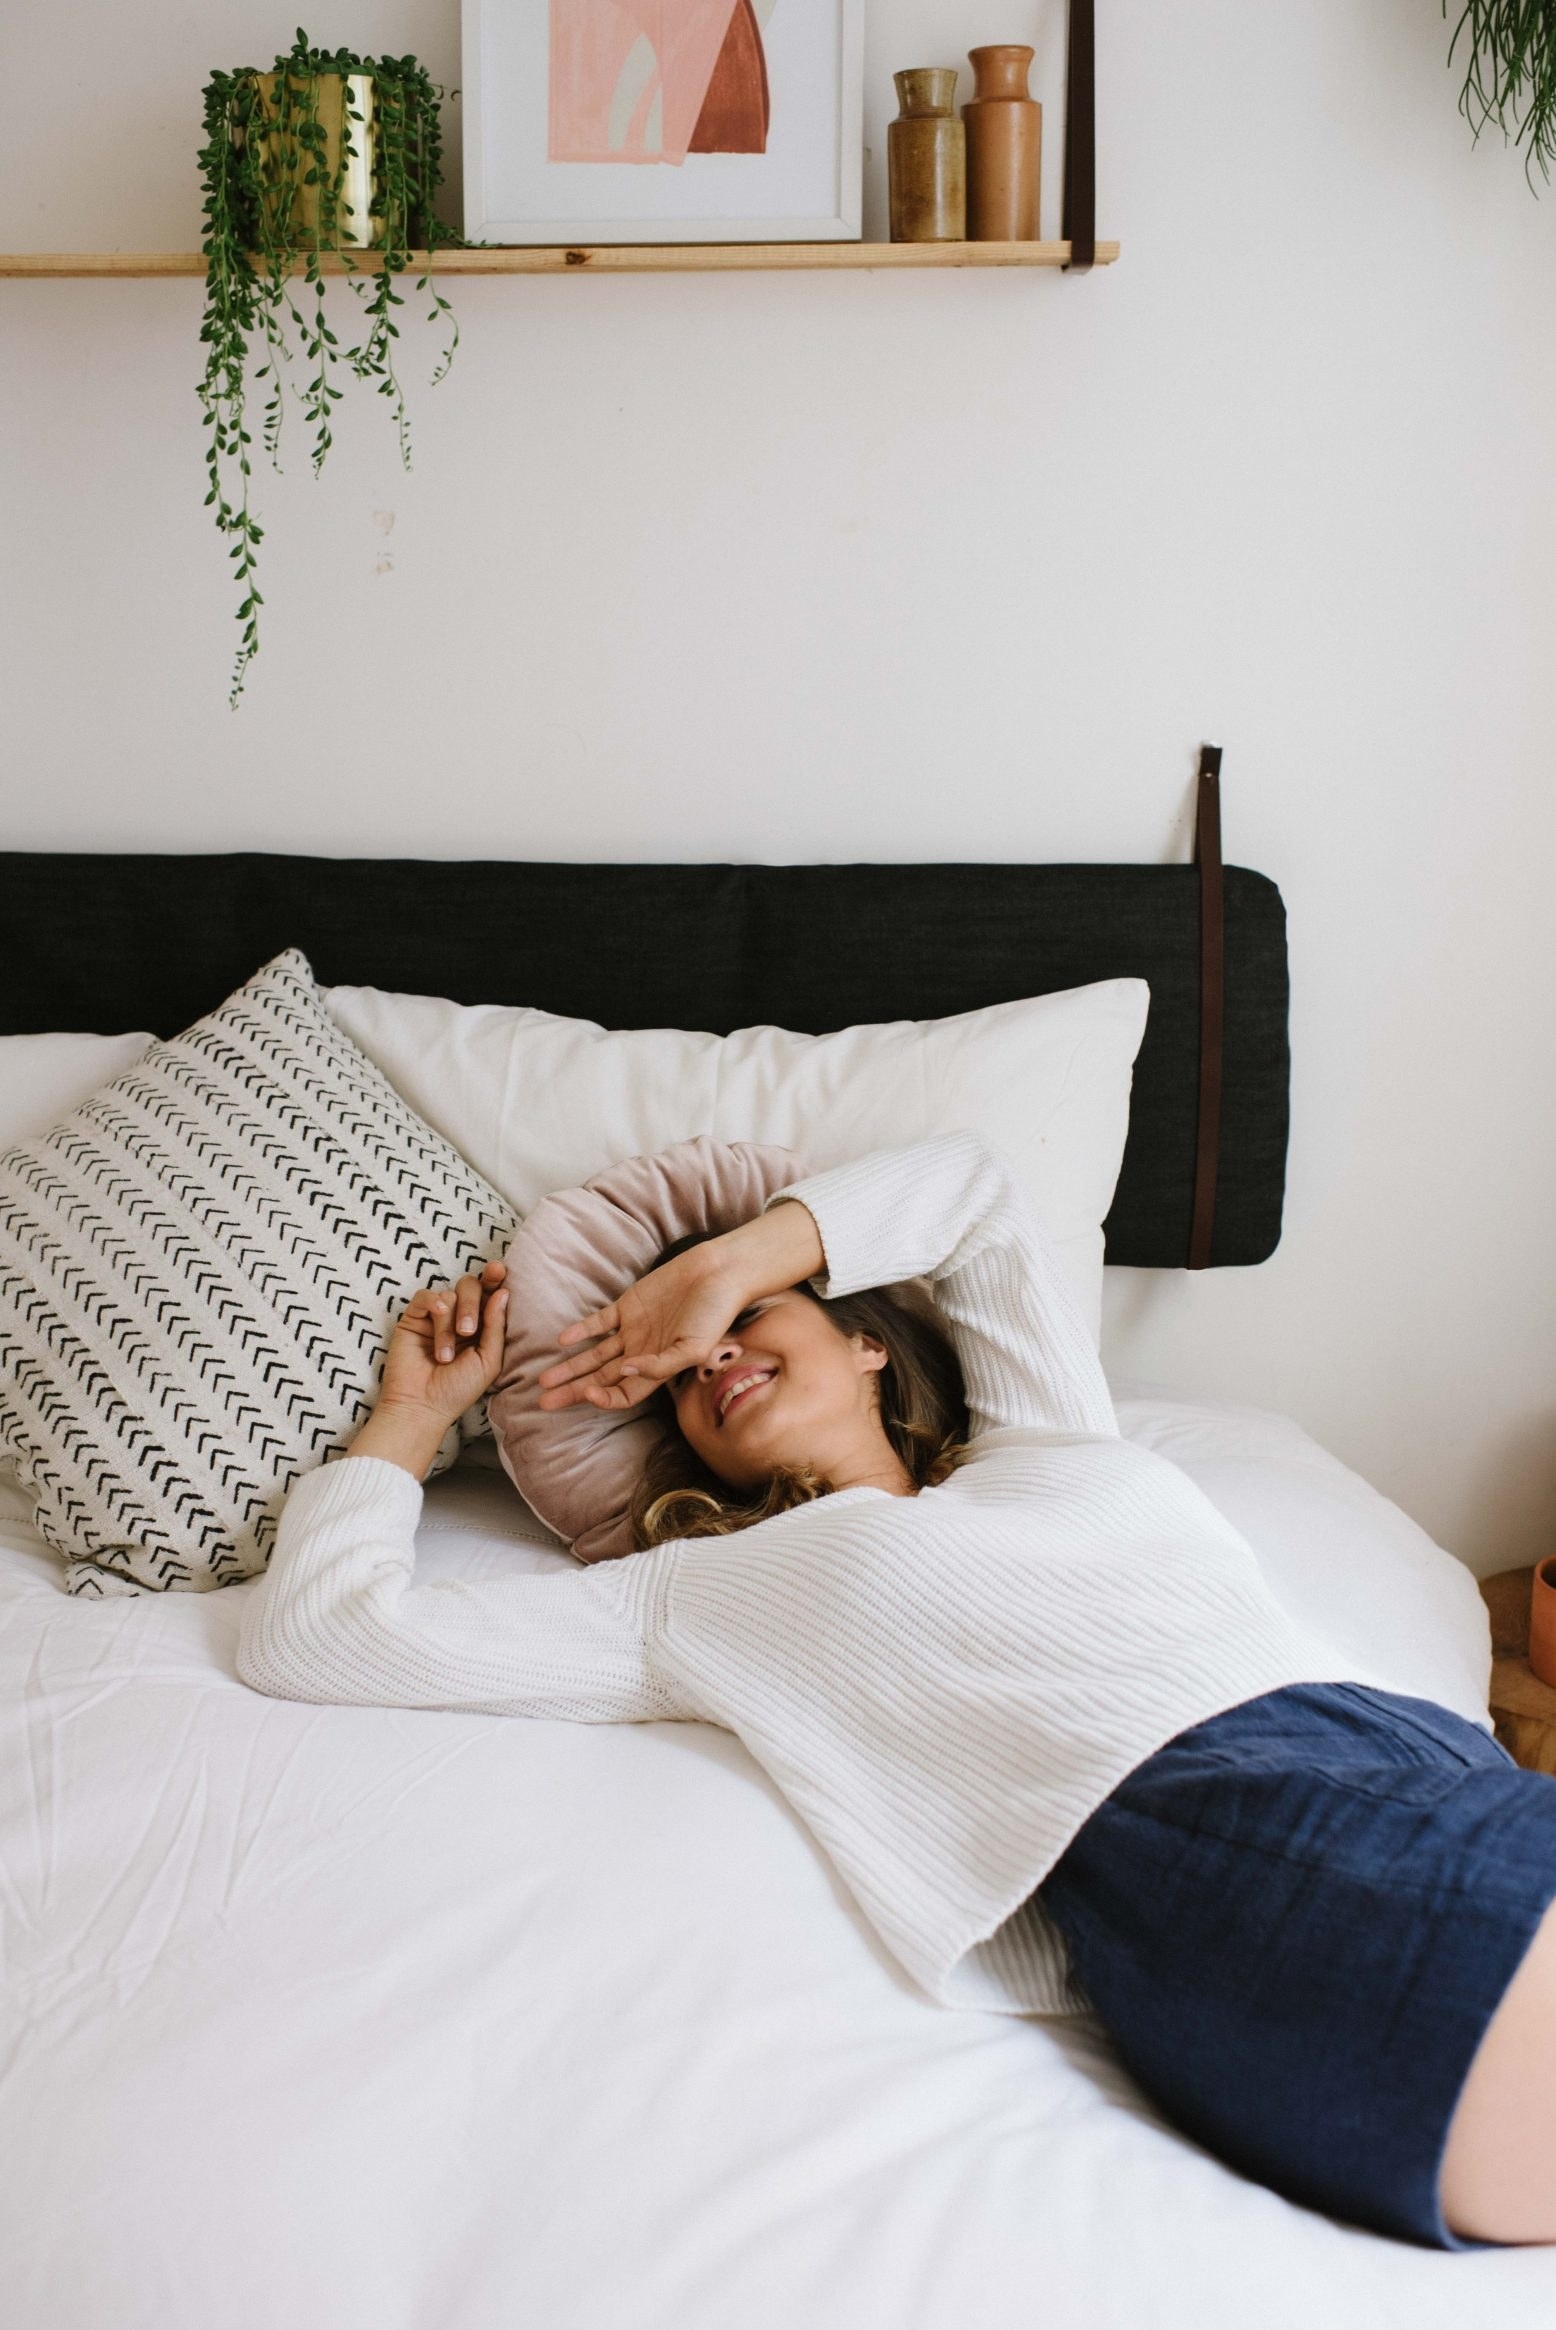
[[0, 0, 1556, 1570]]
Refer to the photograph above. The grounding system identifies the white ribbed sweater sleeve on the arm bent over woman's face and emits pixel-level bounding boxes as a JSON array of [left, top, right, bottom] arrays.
[[769, 1132, 1118, 1438]]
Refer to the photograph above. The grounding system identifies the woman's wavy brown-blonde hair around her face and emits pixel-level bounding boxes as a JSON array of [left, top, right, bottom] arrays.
[[629, 1233, 969, 1552]]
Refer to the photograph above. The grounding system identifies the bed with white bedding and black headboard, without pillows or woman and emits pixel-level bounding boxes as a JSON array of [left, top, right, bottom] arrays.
[[0, 857, 1556, 2330]]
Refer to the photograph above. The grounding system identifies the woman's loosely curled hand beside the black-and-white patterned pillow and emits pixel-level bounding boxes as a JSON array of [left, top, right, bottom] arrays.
[[352, 1263, 508, 1480]]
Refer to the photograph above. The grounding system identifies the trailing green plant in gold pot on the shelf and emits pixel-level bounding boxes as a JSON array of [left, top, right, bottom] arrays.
[[198, 33, 464, 706]]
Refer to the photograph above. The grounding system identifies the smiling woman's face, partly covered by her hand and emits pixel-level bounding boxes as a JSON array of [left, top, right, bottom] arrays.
[[671, 1288, 890, 1489]]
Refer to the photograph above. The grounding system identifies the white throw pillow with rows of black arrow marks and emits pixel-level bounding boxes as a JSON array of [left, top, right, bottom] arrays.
[[0, 953, 515, 1594]]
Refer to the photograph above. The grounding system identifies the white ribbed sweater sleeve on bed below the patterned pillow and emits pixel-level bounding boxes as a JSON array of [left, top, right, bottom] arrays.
[[238, 1456, 689, 1722]]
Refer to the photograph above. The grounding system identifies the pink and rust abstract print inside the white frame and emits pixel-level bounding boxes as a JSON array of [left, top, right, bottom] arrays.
[[547, 0, 773, 165]]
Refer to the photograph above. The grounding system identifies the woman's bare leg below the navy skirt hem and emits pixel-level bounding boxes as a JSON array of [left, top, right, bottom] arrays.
[[1440, 1904, 1556, 2241]]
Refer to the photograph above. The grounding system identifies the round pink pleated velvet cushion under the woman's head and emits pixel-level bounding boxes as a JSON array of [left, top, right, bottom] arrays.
[[487, 1135, 804, 1561]]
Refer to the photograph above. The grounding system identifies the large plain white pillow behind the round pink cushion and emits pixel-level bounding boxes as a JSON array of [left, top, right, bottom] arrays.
[[324, 979, 1151, 1337]]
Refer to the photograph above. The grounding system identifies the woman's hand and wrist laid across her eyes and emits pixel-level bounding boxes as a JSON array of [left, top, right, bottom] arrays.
[[540, 1200, 825, 1410]]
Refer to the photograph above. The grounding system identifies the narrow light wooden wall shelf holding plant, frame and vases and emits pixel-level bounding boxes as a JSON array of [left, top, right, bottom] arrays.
[[0, 242, 1118, 277]]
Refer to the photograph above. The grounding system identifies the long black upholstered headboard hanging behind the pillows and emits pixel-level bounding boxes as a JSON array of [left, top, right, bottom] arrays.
[[0, 853, 1290, 1268]]
